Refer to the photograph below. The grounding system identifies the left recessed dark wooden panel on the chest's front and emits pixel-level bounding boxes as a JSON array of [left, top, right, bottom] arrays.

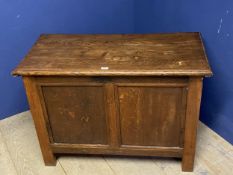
[[41, 85, 108, 145]]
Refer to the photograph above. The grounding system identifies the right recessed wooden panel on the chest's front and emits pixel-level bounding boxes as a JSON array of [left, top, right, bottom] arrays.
[[118, 86, 186, 147]]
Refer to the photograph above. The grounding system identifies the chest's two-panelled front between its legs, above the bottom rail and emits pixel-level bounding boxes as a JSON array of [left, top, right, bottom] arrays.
[[37, 77, 187, 148]]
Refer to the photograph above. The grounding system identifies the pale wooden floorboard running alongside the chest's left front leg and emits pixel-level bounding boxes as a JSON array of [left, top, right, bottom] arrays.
[[0, 112, 65, 175]]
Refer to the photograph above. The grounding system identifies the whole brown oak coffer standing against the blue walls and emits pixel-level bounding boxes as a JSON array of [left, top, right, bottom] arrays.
[[12, 33, 212, 171]]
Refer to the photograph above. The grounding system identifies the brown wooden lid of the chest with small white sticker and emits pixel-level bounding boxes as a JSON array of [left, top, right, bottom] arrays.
[[12, 33, 212, 76]]
